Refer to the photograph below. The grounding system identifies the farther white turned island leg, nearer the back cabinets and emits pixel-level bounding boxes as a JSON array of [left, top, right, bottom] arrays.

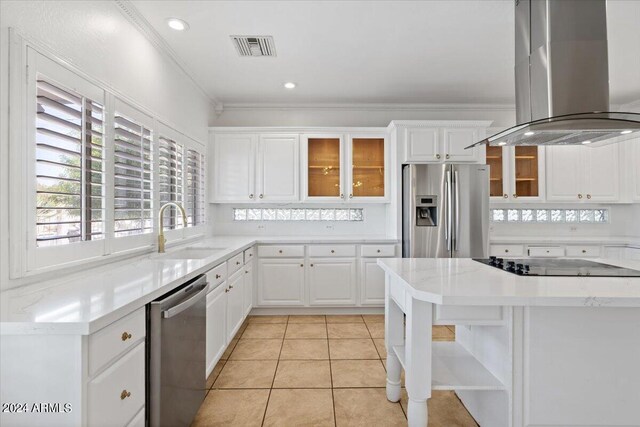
[[384, 275, 404, 402]]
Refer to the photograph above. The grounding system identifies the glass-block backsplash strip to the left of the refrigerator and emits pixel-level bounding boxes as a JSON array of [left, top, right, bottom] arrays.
[[233, 208, 364, 221]]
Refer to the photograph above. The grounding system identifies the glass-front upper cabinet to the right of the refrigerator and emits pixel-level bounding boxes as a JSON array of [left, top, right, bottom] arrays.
[[487, 146, 544, 203]]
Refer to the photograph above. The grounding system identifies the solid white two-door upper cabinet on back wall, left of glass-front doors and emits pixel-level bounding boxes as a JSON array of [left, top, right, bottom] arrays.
[[210, 133, 300, 203]]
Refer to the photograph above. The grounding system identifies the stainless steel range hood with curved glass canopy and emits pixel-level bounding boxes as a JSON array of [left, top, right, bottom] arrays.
[[471, 0, 640, 147]]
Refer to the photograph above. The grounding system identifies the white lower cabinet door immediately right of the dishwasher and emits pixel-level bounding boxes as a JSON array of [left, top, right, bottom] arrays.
[[206, 283, 228, 376]]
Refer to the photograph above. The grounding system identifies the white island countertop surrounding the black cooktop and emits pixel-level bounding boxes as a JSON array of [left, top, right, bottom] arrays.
[[378, 258, 640, 307]]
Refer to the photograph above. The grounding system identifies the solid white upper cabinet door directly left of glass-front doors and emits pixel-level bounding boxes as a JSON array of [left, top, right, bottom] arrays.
[[256, 135, 300, 202]]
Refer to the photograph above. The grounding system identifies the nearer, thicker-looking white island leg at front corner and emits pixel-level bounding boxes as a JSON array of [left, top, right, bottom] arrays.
[[404, 298, 433, 427]]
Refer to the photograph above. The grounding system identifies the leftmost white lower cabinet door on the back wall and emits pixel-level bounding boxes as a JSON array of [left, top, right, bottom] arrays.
[[258, 258, 305, 306]]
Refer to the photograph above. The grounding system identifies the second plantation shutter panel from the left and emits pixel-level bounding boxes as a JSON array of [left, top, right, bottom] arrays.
[[113, 111, 153, 237]]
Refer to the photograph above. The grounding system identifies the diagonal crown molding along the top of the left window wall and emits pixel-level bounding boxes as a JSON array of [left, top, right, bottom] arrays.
[[113, 0, 222, 111]]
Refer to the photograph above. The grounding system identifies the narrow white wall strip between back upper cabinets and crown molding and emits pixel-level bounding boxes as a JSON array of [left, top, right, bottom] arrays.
[[209, 105, 515, 128]]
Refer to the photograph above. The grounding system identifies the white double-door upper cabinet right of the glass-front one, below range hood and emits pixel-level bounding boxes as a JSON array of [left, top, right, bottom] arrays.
[[546, 144, 620, 202]]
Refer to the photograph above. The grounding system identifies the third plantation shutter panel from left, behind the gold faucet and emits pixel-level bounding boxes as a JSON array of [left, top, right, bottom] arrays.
[[158, 136, 185, 229]]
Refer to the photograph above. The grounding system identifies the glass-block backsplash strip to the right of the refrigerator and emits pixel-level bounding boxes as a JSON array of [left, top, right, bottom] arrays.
[[491, 209, 609, 224]]
